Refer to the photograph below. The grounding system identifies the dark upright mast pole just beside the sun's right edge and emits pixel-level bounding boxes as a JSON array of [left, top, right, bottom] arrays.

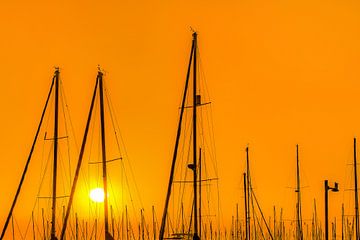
[[98, 71, 109, 239]]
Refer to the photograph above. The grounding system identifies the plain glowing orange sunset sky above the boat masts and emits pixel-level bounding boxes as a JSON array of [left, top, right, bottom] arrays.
[[0, 0, 360, 236]]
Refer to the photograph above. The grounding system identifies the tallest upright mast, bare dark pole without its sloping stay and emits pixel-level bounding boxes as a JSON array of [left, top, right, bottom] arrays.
[[193, 32, 199, 240]]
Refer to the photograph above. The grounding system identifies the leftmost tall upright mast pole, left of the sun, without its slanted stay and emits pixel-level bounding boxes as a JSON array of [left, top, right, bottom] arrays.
[[51, 68, 59, 240]]
